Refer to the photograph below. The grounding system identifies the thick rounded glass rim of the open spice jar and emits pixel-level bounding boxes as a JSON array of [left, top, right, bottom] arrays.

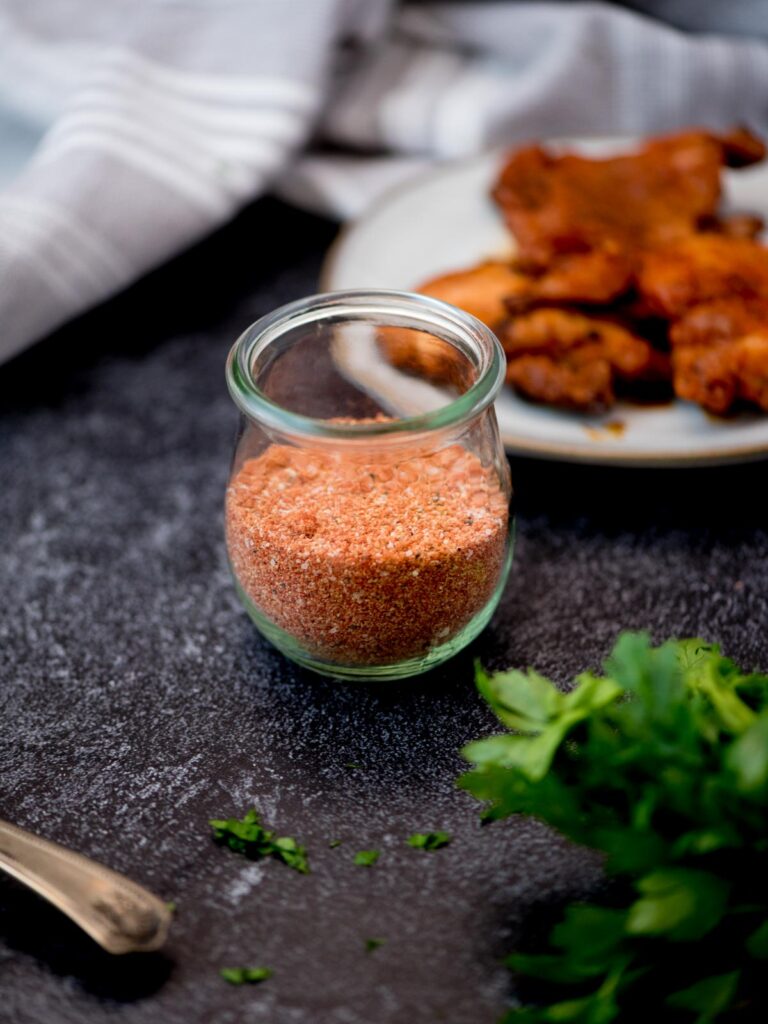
[[226, 288, 506, 440]]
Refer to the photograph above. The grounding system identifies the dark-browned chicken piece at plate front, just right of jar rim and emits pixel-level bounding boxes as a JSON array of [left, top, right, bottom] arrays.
[[500, 309, 669, 409]]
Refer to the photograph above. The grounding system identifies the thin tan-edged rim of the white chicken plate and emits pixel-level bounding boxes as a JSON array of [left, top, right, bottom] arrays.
[[318, 143, 768, 469]]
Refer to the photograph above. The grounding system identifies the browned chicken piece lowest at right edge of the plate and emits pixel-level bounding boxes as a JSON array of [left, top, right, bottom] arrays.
[[670, 296, 768, 414]]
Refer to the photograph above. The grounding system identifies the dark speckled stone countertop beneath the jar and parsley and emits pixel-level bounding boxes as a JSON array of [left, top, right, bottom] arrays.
[[0, 202, 768, 1024]]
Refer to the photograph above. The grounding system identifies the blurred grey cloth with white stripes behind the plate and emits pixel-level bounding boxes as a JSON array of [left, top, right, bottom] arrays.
[[0, 0, 768, 361]]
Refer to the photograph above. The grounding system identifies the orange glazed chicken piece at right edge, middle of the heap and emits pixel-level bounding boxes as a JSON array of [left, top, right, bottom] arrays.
[[636, 234, 768, 319]]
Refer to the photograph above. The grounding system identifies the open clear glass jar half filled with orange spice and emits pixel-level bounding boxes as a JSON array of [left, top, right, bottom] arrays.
[[226, 291, 512, 679]]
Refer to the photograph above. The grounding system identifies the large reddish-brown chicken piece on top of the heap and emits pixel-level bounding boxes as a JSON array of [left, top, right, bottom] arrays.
[[494, 129, 765, 267]]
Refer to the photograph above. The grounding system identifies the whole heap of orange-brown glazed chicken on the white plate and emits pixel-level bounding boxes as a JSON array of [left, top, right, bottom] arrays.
[[391, 121, 768, 413]]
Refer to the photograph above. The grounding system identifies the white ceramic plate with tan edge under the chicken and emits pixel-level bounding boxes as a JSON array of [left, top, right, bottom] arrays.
[[322, 139, 768, 466]]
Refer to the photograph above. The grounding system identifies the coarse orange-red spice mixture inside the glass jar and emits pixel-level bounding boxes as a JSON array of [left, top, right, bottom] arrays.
[[226, 444, 508, 666]]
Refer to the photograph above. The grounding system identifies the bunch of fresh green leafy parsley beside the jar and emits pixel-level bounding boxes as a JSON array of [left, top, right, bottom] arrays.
[[462, 634, 768, 1024]]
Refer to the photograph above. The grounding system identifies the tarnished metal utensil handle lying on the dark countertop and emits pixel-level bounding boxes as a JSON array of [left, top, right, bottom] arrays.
[[0, 820, 171, 953]]
